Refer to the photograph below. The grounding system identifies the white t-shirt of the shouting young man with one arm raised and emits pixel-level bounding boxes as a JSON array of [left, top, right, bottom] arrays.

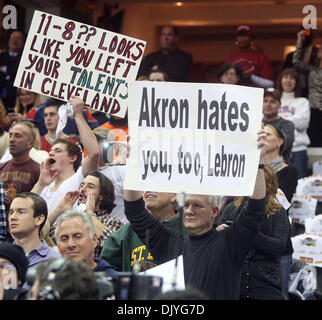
[[40, 167, 84, 212]]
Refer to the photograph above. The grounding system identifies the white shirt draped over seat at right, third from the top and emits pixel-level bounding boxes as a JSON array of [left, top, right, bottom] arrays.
[[288, 194, 318, 224]]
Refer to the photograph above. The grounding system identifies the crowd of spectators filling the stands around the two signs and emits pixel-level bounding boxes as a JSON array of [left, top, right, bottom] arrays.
[[0, 25, 322, 300]]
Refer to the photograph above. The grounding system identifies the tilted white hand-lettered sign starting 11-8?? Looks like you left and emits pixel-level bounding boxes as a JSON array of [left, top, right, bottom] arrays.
[[14, 11, 146, 117]]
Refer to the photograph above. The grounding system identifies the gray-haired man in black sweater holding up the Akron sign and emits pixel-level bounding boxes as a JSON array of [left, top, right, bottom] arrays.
[[124, 130, 267, 300]]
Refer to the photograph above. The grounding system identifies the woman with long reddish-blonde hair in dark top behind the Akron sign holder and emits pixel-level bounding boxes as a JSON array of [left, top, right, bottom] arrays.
[[217, 165, 289, 300]]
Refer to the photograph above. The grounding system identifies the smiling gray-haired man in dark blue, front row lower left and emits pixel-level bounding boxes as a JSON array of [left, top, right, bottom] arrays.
[[55, 210, 117, 277]]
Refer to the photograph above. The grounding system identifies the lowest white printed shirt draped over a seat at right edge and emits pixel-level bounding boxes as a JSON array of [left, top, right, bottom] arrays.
[[292, 233, 322, 267]]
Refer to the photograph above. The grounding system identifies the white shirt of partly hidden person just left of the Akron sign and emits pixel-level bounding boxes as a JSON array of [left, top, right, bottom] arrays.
[[99, 166, 129, 224]]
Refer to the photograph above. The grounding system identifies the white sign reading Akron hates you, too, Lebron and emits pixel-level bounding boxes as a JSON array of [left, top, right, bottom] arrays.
[[125, 81, 263, 196]]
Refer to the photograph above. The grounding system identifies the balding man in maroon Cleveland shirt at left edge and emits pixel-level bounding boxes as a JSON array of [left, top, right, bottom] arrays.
[[0, 121, 40, 204]]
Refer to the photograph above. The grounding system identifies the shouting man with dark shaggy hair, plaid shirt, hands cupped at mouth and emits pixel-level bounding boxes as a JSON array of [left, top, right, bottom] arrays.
[[48, 171, 123, 258]]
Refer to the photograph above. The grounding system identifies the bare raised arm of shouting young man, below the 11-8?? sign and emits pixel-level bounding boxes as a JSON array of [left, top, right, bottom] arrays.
[[70, 96, 99, 176]]
